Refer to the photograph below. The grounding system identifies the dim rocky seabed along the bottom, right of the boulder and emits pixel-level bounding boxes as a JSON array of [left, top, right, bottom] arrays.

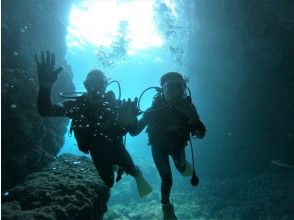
[[104, 172, 294, 220]]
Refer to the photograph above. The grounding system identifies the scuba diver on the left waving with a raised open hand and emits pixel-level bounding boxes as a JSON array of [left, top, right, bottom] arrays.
[[35, 51, 152, 197]]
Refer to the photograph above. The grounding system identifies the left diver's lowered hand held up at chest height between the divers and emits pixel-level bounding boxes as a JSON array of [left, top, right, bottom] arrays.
[[118, 98, 139, 128]]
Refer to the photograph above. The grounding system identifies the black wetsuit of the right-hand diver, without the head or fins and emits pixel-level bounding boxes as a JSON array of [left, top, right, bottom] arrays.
[[139, 95, 206, 204]]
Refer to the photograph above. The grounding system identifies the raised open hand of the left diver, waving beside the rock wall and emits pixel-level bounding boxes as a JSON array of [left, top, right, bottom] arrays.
[[35, 50, 63, 88]]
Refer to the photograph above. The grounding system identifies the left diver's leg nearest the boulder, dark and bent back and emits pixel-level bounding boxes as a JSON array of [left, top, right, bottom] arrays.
[[90, 150, 114, 188]]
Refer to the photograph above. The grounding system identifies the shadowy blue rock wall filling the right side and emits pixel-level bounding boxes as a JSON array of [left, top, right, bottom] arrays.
[[189, 0, 294, 177]]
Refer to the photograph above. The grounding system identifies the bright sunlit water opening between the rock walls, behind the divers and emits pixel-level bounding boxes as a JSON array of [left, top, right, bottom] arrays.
[[59, 0, 194, 156]]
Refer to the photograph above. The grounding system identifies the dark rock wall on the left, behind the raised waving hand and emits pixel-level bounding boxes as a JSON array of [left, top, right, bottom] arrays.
[[1, 0, 74, 190]]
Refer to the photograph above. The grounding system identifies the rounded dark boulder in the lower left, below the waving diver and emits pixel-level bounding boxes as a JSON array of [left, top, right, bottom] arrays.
[[1, 154, 110, 220]]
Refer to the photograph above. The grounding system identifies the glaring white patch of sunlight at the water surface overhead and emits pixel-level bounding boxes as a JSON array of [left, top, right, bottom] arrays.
[[67, 0, 164, 54]]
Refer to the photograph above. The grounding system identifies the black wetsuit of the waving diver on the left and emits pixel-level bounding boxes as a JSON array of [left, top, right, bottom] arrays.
[[38, 88, 139, 188]]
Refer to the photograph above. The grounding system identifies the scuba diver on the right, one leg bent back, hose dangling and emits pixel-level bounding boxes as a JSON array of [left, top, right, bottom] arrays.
[[130, 72, 206, 218]]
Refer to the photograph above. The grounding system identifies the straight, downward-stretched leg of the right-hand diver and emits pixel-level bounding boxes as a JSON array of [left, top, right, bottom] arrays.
[[152, 145, 172, 204]]
